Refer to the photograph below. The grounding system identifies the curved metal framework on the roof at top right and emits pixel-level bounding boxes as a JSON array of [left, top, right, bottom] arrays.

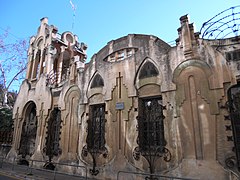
[[200, 5, 240, 39]]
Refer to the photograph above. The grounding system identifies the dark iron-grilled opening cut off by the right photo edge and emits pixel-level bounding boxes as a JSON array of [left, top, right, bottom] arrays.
[[228, 83, 240, 170]]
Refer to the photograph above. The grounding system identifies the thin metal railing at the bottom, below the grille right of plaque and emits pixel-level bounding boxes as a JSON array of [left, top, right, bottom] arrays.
[[117, 171, 197, 180]]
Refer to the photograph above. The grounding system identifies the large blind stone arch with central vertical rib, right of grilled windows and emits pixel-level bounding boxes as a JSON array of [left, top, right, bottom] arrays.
[[173, 59, 218, 160]]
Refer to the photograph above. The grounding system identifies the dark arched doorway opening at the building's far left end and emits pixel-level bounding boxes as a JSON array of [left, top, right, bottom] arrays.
[[18, 101, 38, 159]]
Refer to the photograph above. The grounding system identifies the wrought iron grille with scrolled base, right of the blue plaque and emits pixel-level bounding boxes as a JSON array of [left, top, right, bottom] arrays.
[[133, 97, 171, 179]]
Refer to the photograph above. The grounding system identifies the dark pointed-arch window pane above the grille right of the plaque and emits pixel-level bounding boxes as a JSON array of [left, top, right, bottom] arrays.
[[139, 62, 159, 79]]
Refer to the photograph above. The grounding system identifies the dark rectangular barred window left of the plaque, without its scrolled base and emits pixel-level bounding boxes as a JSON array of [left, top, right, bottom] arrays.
[[87, 104, 105, 153]]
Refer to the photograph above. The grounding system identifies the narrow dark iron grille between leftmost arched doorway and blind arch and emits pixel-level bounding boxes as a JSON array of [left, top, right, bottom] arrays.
[[45, 108, 61, 162]]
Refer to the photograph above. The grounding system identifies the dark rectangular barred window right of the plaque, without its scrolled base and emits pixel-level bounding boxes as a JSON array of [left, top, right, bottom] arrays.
[[138, 97, 166, 153]]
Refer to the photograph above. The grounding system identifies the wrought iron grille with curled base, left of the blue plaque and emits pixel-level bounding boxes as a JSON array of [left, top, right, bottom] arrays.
[[82, 104, 108, 175]]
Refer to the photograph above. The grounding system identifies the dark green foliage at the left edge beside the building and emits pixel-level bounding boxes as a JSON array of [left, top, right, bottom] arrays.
[[0, 108, 13, 131]]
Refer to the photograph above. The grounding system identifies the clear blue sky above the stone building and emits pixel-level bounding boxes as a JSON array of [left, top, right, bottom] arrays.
[[0, 0, 240, 90]]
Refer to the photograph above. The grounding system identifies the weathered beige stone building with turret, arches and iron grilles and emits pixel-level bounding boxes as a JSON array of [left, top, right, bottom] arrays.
[[8, 16, 240, 179]]
